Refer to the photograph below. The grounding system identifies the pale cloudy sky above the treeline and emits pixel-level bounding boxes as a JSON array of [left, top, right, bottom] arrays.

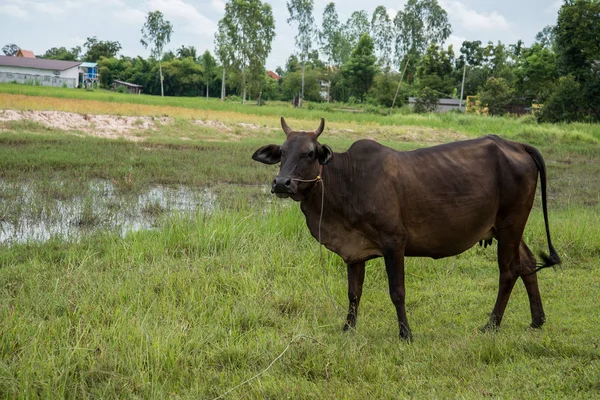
[[0, 0, 562, 70]]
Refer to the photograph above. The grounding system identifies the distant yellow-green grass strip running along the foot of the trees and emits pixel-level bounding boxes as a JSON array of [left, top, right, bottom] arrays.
[[0, 84, 600, 145]]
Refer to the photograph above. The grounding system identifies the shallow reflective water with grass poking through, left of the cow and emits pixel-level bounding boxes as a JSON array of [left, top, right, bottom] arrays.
[[0, 180, 216, 244]]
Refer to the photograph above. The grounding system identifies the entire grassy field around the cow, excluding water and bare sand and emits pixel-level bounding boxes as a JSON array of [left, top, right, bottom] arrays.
[[0, 85, 600, 399]]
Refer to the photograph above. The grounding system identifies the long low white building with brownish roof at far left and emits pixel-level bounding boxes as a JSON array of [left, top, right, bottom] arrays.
[[0, 56, 82, 88]]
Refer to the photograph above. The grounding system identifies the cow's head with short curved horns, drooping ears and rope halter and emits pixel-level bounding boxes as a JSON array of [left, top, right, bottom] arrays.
[[252, 117, 333, 201]]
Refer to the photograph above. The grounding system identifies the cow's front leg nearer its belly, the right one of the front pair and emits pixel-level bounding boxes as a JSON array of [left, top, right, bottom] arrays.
[[383, 249, 412, 340]]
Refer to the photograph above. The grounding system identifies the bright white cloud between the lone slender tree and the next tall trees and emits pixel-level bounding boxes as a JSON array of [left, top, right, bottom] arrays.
[[148, 0, 217, 37]]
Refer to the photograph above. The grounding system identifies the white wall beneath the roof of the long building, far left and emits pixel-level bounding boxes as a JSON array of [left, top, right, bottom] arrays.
[[0, 65, 79, 88]]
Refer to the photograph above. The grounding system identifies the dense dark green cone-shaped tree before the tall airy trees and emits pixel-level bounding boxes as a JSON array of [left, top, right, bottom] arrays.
[[342, 33, 377, 102]]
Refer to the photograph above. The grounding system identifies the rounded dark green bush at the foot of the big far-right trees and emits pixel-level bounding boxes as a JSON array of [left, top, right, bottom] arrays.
[[538, 76, 585, 122]]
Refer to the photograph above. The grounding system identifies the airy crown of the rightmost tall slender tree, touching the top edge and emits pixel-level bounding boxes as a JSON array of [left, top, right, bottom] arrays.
[[394, 0, 452, 73]]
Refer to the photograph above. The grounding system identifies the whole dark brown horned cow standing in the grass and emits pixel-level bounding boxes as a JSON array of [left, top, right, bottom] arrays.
[[252, 118, 560, 339]]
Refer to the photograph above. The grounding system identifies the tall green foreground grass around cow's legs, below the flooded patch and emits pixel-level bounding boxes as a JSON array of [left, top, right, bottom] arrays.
[[0, 203, 600, 398]]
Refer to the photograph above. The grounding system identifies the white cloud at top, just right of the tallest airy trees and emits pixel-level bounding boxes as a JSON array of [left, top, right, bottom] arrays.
[[440, 0, 510, 31]]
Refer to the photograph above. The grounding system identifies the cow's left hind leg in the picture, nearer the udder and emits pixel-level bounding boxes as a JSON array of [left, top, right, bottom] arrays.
[[482, 225, 523, 331]]
